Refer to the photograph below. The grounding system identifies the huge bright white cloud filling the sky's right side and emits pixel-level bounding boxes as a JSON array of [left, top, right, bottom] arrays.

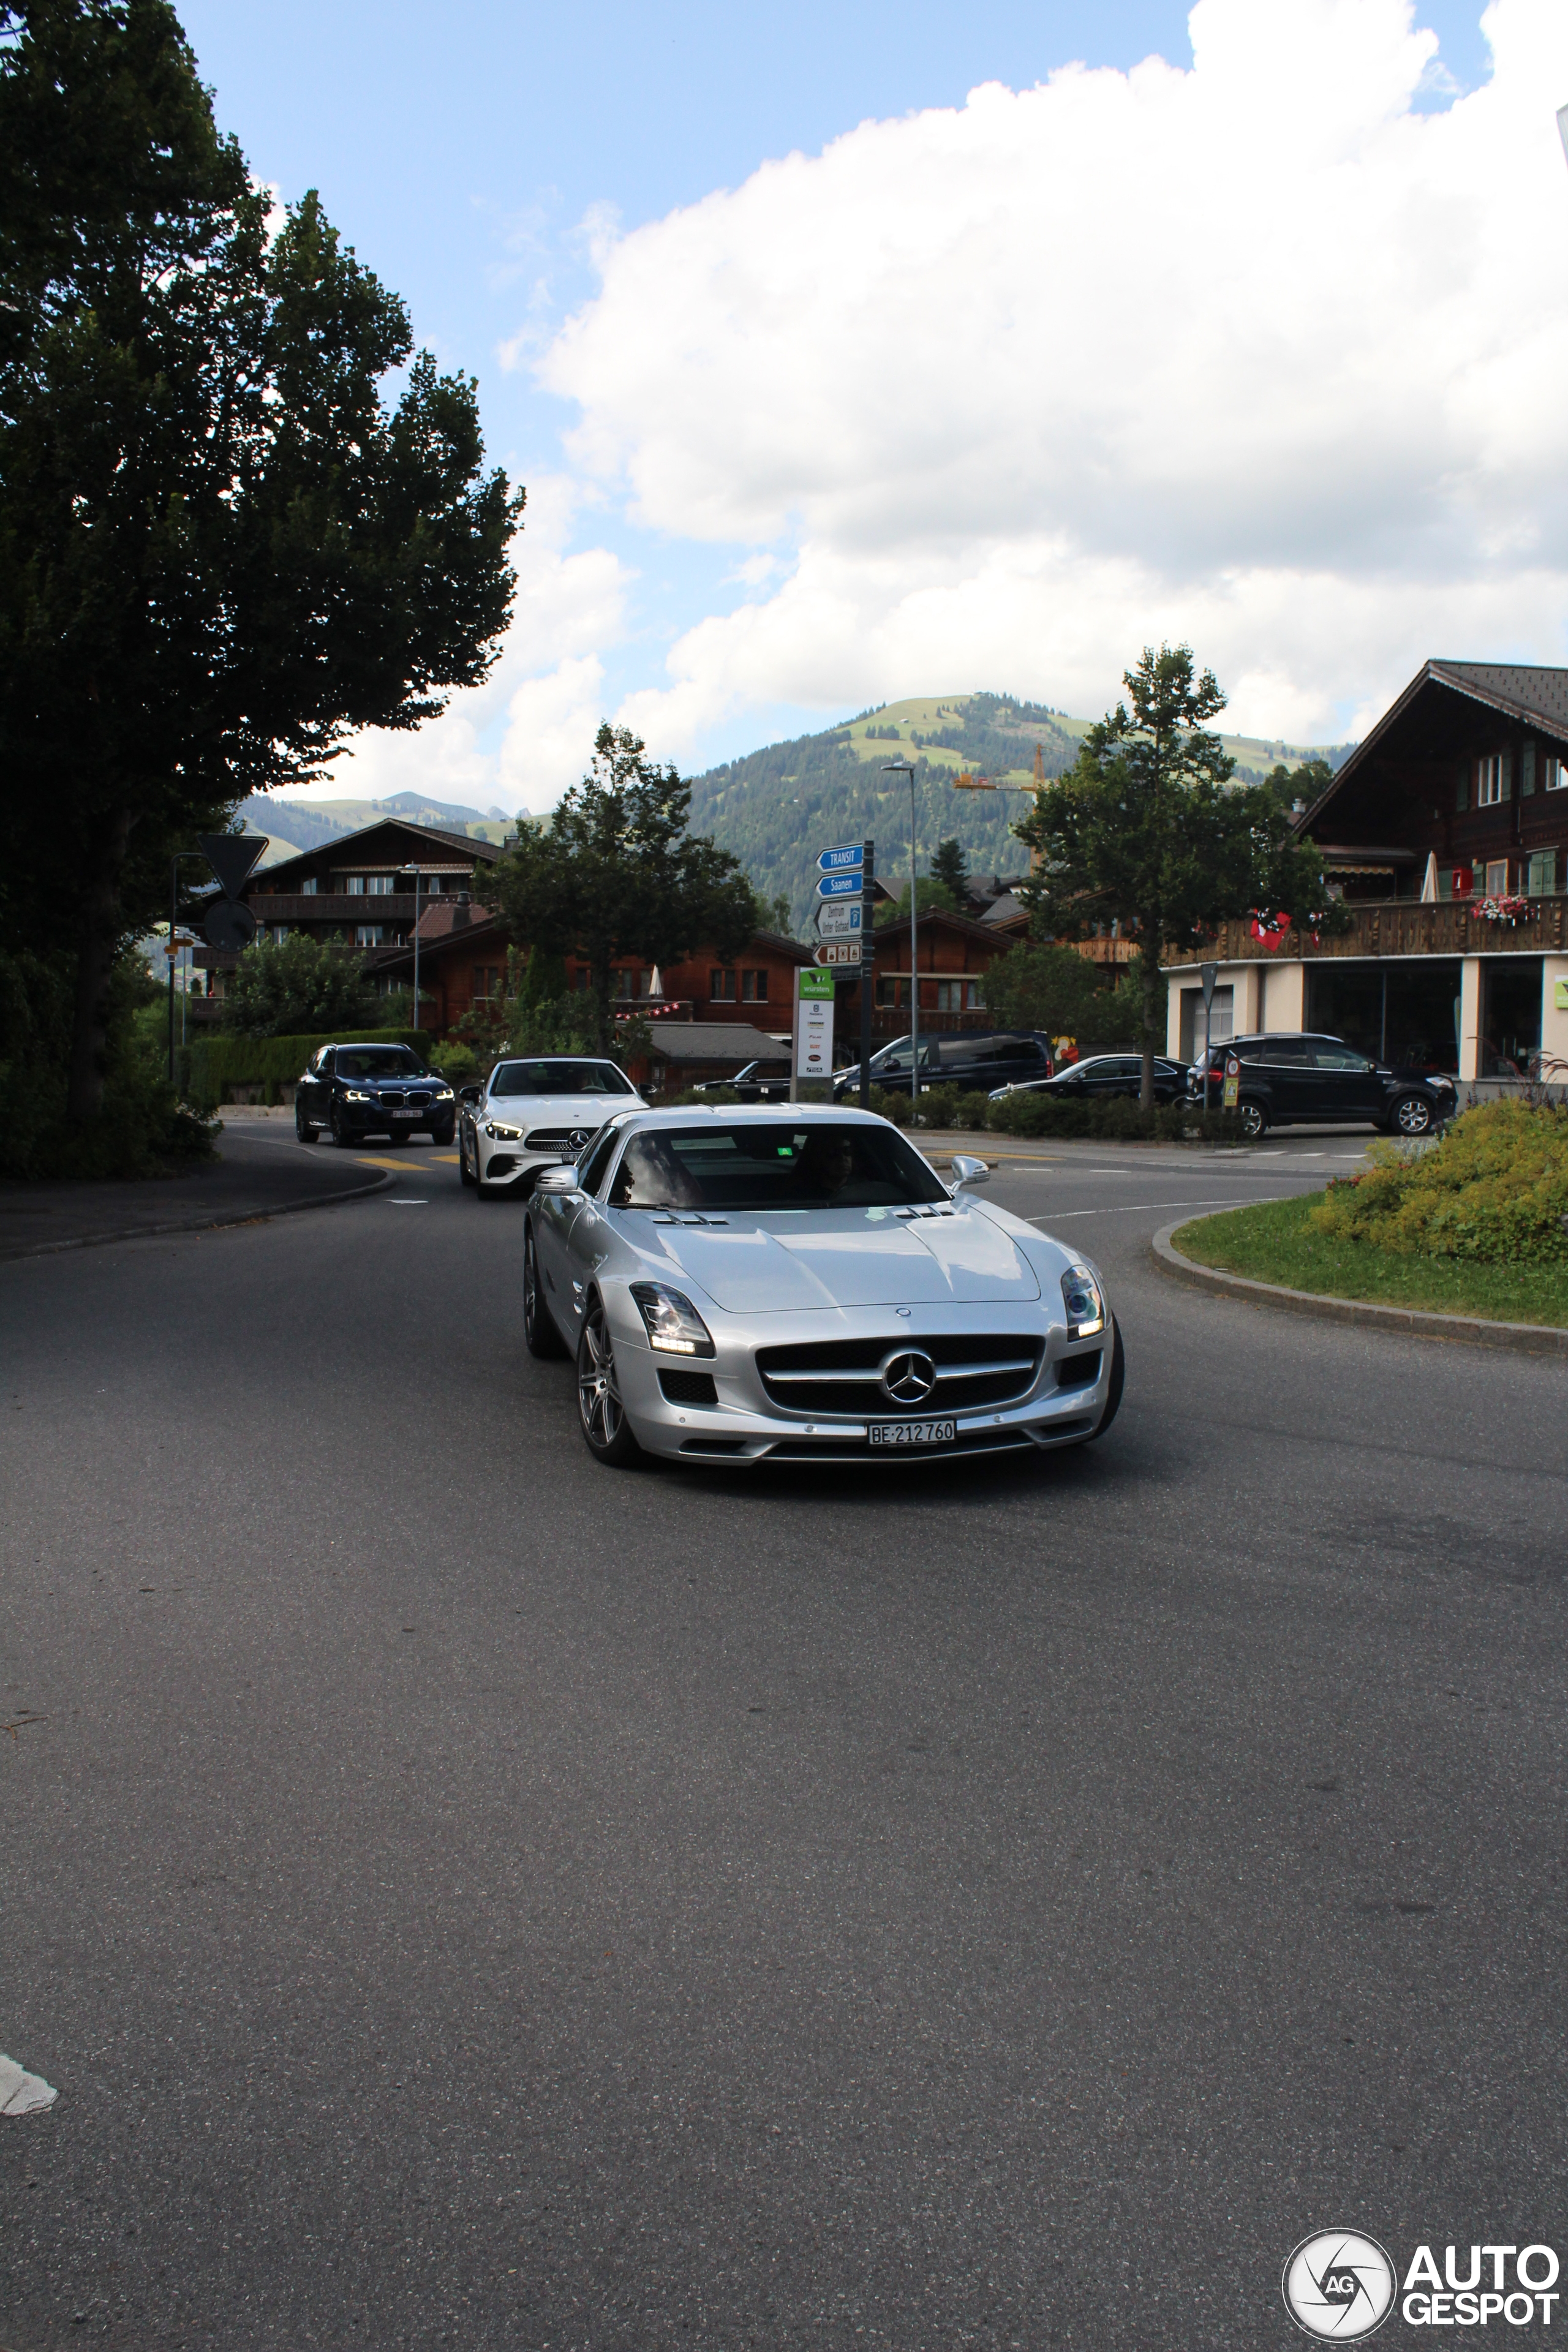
[[529, 0, 1568, 764]]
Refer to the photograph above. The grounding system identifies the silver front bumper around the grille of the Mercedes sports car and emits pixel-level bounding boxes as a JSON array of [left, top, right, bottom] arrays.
[[604, 1289, 1117, 1468]]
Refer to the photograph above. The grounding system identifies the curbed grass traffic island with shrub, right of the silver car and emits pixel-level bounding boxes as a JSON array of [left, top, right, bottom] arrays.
[[1170, 1101, 1568, 1329]]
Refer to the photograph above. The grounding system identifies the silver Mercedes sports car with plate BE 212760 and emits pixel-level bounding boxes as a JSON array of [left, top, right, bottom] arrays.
[[522, 1103, 1124, 1465]]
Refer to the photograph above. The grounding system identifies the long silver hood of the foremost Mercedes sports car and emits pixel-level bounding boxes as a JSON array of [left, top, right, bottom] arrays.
[[620, 1207, 1039, 1315]]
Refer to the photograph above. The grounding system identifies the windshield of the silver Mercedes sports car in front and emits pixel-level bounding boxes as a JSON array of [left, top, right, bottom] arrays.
[[609, 1120, 948, 1212]]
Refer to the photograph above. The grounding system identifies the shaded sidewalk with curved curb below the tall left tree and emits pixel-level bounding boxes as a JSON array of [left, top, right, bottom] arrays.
[[0, 1117, 393, 1258]]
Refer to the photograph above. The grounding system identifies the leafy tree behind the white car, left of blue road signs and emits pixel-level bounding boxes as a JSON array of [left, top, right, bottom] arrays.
[[486, 725, 757, 1051]]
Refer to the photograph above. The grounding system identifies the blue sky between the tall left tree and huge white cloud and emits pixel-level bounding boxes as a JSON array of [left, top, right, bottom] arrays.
[[181, 0, 1568, 802]]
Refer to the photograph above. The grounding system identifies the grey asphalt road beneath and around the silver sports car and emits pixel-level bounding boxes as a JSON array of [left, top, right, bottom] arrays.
[[0, 1136, 1568, 2352]]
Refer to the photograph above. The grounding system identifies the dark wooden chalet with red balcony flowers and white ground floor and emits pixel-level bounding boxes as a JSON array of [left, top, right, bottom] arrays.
[[1166, 661, 1568, 1087]]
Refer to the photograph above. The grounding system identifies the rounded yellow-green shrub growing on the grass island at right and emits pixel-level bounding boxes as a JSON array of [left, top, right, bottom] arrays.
[[1312, 1101, 1568, 1265]]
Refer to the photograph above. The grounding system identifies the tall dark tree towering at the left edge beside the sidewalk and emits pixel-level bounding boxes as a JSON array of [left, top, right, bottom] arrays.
[[0, 0, 522, 1117]]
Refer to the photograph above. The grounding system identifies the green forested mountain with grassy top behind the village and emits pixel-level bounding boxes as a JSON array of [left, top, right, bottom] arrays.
[[691, 694, 1352, 932]]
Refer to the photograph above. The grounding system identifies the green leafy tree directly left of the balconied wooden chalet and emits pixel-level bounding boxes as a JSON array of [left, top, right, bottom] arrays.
[[1016, 644, 1329, 1108]]
